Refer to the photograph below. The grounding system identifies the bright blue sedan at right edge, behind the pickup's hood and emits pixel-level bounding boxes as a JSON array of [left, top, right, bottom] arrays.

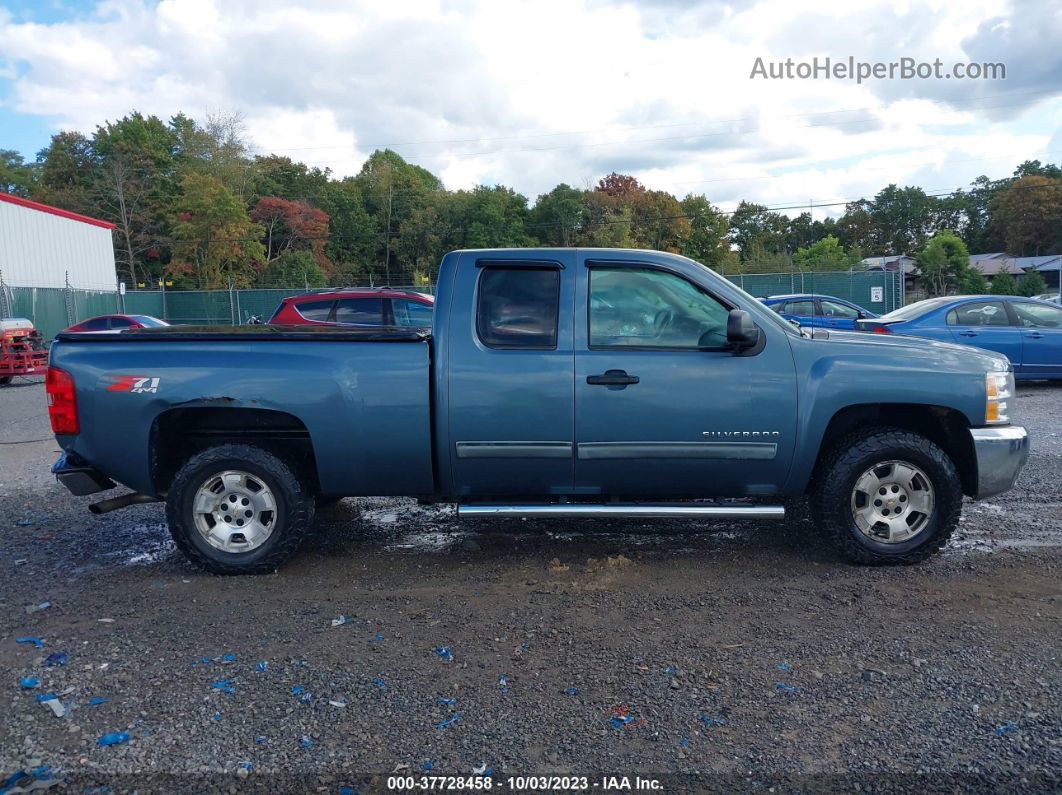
[[857, 295, 1062, 379]]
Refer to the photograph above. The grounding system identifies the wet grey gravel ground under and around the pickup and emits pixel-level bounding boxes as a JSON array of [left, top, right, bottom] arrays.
[[0, 380, 1062, 793]]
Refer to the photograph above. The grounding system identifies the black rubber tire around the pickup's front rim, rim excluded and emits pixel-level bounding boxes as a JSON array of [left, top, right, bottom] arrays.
[[810, 428, 962, 566]]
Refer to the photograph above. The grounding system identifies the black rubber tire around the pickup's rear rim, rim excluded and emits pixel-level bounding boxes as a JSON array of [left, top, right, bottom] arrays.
[[166, 444, 313, 574]]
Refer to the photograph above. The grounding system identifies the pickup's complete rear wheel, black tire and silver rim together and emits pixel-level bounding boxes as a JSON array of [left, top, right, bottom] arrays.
[[166, 445, 313, 574]]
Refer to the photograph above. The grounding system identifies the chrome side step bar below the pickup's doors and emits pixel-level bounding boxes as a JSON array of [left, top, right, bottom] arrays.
[[458, 502, 786, 519]]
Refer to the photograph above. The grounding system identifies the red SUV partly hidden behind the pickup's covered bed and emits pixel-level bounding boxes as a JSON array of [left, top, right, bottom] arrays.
[[269, 288, 435, 328]]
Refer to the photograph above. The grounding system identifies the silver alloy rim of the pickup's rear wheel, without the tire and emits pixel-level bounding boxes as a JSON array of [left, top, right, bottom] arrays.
[[192, 469, 276, 552]]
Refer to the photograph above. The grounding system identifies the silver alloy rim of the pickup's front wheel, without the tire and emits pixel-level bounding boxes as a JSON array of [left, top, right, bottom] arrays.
[[852, 461, 933, 543]]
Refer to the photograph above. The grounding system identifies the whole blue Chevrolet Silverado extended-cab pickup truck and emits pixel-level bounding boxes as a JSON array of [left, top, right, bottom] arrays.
[[46, 248, 1028, 573]]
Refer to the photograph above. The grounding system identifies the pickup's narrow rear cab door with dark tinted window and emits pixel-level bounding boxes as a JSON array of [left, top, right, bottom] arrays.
[[445, 252, 576, 497]]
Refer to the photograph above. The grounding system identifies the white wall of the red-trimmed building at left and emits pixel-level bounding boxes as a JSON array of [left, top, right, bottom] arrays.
[[0, 200, 117, 290]]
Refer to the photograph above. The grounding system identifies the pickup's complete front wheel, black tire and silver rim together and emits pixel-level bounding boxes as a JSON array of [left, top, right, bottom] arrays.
[[810, 428, 962, 566]]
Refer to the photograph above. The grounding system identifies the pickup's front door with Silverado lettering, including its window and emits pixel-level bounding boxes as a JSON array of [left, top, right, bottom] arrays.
[[575, 253, 797, 497]]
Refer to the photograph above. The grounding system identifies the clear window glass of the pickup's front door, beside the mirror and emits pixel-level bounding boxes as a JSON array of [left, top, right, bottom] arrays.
[[589, 267, 730, 350]]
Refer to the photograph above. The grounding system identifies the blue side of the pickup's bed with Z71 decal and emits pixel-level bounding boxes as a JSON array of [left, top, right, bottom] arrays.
[[52, 325, 434, 495]]
